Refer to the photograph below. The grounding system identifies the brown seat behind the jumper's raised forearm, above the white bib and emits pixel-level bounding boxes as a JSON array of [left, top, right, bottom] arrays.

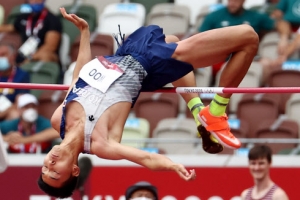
[[70, 32, 114, 62]]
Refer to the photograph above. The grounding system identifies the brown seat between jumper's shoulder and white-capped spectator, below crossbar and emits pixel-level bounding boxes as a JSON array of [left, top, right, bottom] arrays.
[[38, 90, 67, 120]]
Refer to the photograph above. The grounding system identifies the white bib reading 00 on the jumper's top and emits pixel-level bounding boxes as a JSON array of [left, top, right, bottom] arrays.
[[79, 56, 124, 93]]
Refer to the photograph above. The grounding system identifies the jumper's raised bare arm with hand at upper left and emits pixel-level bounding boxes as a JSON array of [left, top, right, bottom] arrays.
[[60, 8, 92, 81]]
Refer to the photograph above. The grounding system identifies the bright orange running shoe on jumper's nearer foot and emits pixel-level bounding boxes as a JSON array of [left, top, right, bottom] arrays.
[[198, 106, 241, 149]]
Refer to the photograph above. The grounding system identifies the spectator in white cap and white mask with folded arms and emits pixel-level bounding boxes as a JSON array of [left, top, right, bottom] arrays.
[[0, 94, 59, 153]]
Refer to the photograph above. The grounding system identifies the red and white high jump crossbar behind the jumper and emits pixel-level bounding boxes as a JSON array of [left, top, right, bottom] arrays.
[[0, 82, 300, 94]]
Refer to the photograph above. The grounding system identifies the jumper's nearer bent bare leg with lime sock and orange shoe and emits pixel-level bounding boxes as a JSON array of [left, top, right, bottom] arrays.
[[172, 25, 259, 149]]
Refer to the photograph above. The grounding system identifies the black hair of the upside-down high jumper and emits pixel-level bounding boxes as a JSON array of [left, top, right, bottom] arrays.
[[37, 174, 78, 198]]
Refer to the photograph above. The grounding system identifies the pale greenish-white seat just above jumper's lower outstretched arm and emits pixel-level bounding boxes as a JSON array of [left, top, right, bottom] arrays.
[[121, 117, 150, 148]]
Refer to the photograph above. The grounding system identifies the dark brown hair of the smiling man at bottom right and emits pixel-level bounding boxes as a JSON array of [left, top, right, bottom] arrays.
[[248, 145, 272, 163]]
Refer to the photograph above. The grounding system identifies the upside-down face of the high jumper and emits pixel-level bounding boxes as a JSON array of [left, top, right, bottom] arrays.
[[42, 145, 79, 188]]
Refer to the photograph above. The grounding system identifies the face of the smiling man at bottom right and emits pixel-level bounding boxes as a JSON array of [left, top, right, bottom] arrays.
[[249, 158, 271, 181]]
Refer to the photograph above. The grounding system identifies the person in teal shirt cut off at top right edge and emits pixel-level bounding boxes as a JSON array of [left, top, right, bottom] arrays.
[[271, 0, 300, 54]]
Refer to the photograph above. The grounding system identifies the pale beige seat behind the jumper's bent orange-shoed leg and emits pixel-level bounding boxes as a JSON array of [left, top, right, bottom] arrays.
[[215, 61, 262, 114]]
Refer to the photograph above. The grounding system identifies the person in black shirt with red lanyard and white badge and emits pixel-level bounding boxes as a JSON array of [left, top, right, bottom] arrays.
[[0, 0, 62, 62]]
